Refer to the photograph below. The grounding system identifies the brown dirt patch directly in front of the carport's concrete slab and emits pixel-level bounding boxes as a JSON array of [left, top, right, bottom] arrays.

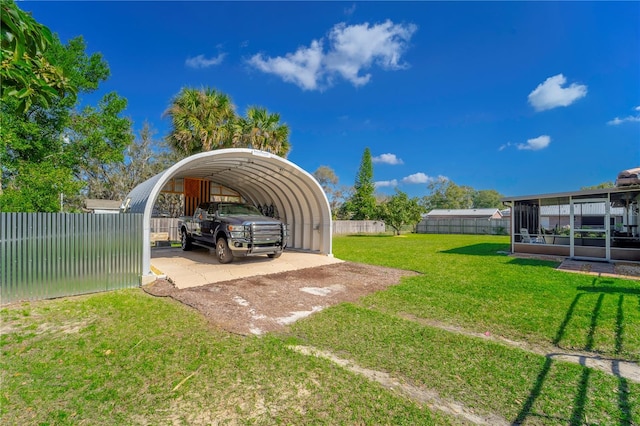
[[144, 262, 418, 335]]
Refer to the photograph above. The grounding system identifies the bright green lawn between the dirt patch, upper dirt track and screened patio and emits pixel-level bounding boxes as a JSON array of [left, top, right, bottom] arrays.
[[334, 235, 640, 362]]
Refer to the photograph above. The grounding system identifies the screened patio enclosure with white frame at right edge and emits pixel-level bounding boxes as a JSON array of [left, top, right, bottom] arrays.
[[502, 186, 640, 262]]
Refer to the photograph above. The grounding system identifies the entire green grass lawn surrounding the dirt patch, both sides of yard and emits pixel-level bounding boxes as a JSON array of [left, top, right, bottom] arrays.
[[0, 235, 640, 425]]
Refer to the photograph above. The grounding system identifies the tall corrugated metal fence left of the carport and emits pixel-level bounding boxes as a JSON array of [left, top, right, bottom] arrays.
[[0, 213, 142, 304]]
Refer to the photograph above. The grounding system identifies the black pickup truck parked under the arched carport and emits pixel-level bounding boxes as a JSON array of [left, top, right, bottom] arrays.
[[178, 202, 287, 263]]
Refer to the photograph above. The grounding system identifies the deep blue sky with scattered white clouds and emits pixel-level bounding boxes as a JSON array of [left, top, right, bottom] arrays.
[[25, 1, 640, 196]]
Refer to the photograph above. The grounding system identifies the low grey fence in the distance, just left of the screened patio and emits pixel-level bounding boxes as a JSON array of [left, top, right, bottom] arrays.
[[416, 218, 510, 235]]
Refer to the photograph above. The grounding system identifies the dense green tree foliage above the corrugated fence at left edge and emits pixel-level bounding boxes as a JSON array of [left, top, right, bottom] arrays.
[[0, 5, 133, 212]]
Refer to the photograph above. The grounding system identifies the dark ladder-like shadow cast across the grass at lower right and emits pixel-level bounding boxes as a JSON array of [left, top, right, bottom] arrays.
[[513, 278, 640, 426]]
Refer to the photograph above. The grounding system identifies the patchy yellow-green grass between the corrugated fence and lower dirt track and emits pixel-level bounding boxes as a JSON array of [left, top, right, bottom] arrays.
[[0, 290, 449, 425]]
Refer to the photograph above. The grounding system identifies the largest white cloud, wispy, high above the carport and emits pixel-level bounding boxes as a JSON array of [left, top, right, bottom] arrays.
[[249, 20, 417, 90]]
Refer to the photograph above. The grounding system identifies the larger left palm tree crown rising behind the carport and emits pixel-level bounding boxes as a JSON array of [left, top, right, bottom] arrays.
[[163, 87, 236, 155]]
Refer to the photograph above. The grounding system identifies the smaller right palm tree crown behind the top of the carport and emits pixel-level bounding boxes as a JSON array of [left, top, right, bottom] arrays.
[[233, 106, 291, 157]]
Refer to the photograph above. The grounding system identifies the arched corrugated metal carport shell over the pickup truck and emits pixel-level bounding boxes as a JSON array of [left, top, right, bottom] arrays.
[[125, 148, 331, 275]]
